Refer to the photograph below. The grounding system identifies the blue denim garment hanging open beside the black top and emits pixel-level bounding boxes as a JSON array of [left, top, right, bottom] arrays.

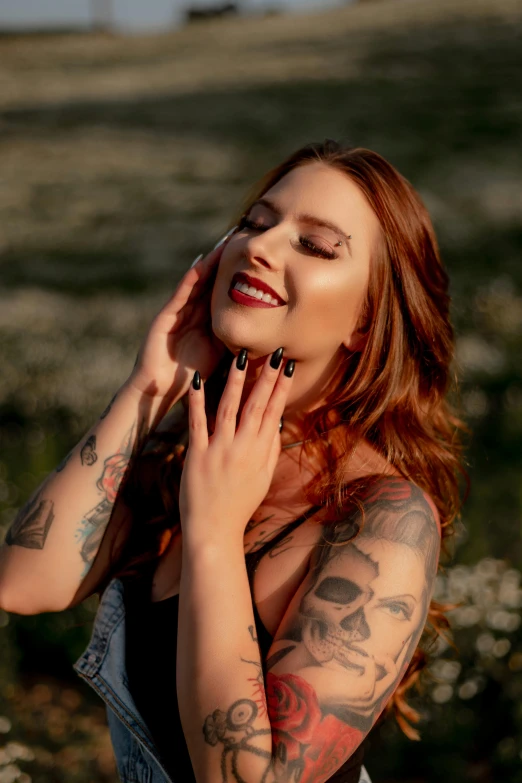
[[74, 579, 371, 783]]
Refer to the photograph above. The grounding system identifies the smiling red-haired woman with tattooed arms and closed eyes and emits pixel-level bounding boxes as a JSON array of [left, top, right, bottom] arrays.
[[0, 141, 459, 783]]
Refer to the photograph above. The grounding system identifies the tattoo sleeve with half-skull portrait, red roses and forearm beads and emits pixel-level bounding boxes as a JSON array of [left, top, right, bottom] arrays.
[[203, 477, 440, 783]]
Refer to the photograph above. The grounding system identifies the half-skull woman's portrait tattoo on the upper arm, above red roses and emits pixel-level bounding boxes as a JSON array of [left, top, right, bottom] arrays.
[[274, 477, 440, 731]]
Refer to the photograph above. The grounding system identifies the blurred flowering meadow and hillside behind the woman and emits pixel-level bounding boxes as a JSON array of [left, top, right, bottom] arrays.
[[0, 0, 522, 783]]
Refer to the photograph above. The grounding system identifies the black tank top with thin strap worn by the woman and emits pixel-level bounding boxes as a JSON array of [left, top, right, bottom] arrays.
[[124, 507, 364, 783]]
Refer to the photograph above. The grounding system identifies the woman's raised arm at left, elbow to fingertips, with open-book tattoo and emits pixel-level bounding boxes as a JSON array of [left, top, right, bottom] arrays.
[[0, 244, 230, 614]]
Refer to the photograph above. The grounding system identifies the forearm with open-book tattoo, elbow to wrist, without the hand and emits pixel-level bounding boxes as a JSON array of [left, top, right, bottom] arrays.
[[0, 384, 158, 614]]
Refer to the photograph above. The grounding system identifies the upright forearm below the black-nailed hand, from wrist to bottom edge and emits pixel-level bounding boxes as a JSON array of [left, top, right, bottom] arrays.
[[177, 540, 272, 783]]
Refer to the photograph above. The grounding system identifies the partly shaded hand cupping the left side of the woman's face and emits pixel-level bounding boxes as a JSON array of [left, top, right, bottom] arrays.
[[128, 228, 235, 402]]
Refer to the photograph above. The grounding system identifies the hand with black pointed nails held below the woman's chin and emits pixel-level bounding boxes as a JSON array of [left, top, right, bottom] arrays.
[[180, 348, 295, 546]]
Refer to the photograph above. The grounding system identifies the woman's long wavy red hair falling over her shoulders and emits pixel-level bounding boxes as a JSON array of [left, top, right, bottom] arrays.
[[112, 140, 465, 738]]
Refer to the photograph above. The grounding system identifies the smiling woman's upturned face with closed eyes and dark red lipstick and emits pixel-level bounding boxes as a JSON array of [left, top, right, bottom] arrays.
[[211, 162, 379, 364]]
